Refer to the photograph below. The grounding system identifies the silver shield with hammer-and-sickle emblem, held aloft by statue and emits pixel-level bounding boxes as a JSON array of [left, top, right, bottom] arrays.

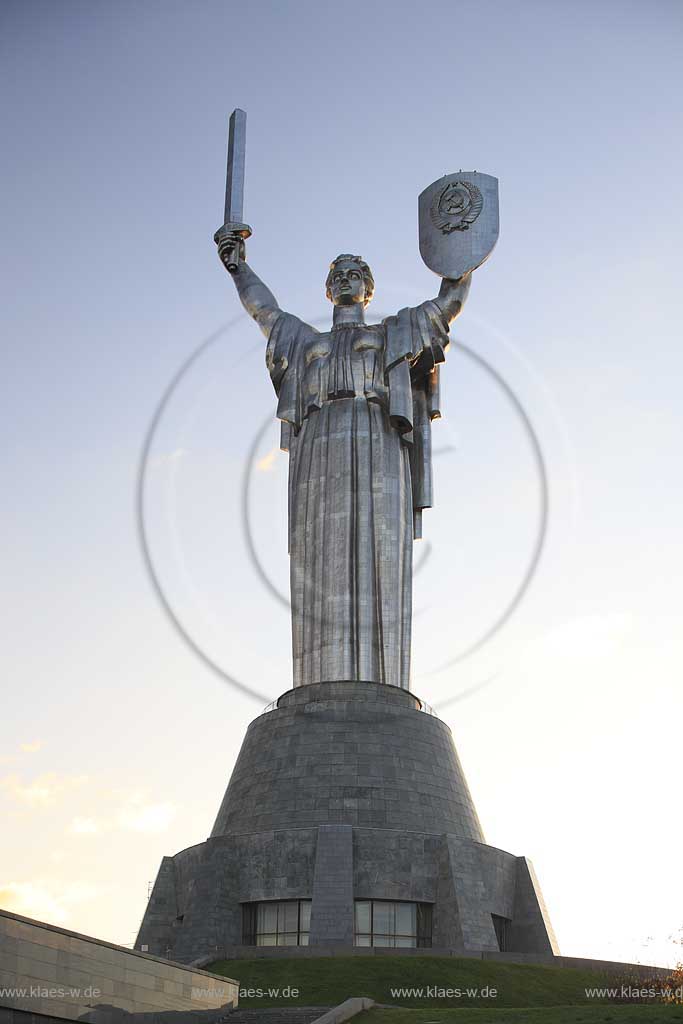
[[418, 171, 499, 278]]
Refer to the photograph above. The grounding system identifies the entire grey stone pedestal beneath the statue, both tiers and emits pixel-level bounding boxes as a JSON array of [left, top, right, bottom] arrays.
[[136, 682, 557, 963]]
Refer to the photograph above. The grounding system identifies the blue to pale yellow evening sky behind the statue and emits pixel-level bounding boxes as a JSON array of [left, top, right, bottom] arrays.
[[0, 0, 683, 963]]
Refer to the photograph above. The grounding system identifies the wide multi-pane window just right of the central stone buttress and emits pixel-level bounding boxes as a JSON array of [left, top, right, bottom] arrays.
[[353, 899, 432, 949]]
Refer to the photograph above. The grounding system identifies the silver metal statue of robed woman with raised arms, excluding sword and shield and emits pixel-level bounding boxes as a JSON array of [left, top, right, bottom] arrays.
[[218, 232, 470, 689]]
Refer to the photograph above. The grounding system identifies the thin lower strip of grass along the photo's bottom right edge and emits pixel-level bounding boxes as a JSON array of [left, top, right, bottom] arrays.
[[353, 1006, 683, 1024]]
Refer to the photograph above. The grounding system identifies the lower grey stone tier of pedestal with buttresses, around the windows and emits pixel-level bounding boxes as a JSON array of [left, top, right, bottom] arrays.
[[136, 825, 558, 963]]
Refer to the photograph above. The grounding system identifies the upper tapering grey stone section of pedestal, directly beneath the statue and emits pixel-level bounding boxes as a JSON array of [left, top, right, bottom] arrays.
[[211, 683, 484, 843]]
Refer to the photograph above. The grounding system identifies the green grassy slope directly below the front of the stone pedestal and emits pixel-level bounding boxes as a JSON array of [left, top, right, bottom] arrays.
[[207, 956, 647, 1011]]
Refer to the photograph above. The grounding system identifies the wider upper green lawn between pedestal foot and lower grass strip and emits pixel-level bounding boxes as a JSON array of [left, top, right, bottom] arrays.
[[206, 956, 683, 1011]]
